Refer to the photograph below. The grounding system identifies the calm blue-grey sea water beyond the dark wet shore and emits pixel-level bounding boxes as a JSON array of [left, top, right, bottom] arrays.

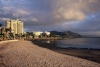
[[56, 38, 100, 49]]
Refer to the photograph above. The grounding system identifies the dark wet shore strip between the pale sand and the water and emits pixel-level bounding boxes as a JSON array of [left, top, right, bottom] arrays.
[[31, 40, 100, 63]]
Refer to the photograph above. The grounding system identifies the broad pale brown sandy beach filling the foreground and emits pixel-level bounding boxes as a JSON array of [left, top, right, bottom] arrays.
[[0, 41, 100, 67]]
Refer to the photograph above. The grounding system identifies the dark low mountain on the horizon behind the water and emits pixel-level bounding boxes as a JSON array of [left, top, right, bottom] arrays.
[[50, 31, 81, 38]]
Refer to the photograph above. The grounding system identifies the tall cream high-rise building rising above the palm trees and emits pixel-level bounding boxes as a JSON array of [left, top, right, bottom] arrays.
[[6, 19, 23, 34]]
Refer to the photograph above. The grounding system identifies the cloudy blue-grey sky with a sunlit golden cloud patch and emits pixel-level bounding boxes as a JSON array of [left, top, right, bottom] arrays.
[[0, 0, 100, 36]]
